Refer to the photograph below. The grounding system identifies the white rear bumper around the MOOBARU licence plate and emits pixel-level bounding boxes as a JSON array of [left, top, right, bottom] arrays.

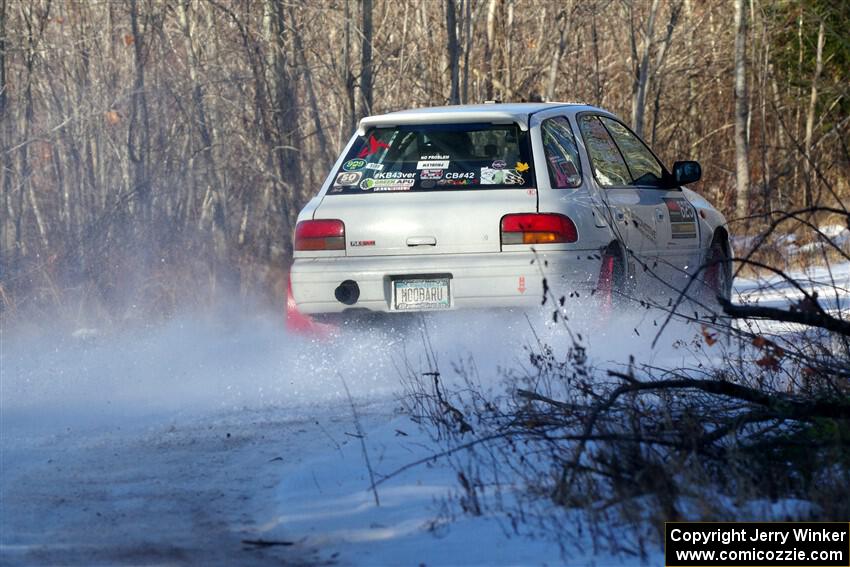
[[290, 250, 601, 314]]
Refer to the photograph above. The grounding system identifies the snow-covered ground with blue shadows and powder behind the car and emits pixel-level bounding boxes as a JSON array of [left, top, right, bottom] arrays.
[[0, 266, 850, 567]]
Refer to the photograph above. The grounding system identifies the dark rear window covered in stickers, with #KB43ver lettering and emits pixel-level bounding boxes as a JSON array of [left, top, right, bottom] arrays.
[[328, 124, 534, 195]]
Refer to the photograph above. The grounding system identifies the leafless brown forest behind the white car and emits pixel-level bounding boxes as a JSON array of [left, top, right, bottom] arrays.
[[0, 0, 850, 324]]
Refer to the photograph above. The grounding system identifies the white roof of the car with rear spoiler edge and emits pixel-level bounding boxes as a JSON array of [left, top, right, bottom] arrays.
[[358, 102, 607, 135]]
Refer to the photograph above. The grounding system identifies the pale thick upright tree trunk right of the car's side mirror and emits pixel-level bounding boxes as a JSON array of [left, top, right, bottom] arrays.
[[735, 0, 750, 218]]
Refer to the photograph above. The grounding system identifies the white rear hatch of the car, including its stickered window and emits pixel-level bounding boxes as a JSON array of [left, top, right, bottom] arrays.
[[314, 123, 537, 256]]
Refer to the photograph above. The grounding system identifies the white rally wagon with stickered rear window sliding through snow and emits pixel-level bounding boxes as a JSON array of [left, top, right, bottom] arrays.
[[288, 103, 731, 319]]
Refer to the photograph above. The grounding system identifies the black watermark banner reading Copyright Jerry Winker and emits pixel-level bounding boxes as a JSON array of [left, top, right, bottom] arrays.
[[664, 522, 850, 567]]
